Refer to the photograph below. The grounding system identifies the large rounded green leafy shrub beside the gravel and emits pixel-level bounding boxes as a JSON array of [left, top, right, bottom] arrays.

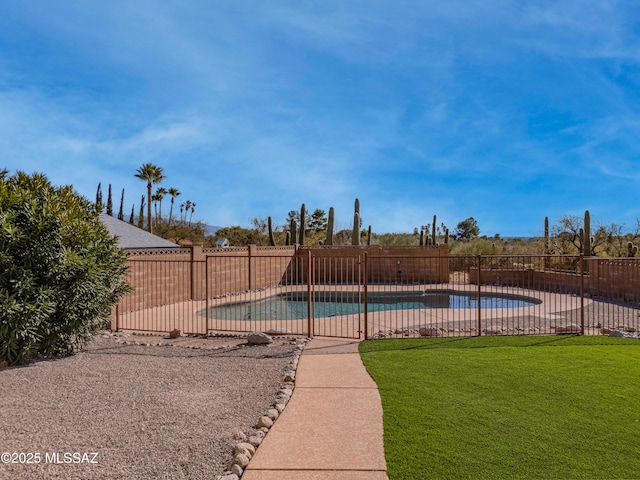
[[0, 171, 129, 365]]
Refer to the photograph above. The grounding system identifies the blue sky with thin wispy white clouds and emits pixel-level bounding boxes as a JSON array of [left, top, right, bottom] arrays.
[[0, 0, 640, 236]]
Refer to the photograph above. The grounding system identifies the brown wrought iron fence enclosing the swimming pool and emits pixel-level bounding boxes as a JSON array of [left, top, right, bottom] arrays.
[[115, 249, 640, 338]]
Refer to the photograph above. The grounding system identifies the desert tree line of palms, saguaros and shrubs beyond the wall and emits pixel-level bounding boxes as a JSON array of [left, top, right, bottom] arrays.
[[96, 168, 640, 257]]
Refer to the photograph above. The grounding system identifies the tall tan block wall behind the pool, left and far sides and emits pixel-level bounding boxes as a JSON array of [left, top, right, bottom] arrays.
[[118, 245, 449, 322]]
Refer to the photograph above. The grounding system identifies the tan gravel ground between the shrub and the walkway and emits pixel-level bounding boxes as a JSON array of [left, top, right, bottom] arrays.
[[0, 336, 295, 479]]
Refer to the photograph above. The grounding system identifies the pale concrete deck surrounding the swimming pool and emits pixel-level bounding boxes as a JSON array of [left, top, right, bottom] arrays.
[[118, 285, 592, 339]]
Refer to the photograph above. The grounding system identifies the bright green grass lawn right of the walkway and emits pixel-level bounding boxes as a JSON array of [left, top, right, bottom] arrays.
[[360, 336, 640, 480]]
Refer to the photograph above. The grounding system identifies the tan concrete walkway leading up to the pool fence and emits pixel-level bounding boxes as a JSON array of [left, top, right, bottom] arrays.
[[242, 338, 387, 480]]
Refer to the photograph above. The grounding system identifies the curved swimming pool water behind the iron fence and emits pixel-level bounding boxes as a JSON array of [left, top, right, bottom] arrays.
[[201, 290, 542, 320]]
